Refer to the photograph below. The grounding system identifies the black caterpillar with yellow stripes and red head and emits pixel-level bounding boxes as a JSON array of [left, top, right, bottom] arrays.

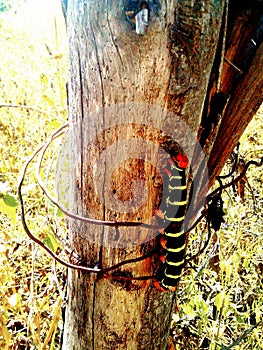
[[154, 154, 188, 292]]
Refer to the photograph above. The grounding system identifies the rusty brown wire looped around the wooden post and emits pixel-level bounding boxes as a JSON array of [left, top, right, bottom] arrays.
[[18, 124, 263, 280]]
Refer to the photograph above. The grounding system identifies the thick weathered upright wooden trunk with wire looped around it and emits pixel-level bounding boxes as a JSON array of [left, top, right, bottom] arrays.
[[63, 0, 262, 350]]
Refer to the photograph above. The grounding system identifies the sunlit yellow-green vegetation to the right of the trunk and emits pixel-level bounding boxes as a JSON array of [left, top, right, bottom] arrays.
[[173, 117, 263, 350]]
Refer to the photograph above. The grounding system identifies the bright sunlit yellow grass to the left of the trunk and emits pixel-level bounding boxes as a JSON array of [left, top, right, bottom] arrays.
[[0, 0, 67, 349]]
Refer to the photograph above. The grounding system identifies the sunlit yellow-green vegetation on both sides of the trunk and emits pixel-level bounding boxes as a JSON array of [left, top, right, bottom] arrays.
[[0, 1, 263, 350]]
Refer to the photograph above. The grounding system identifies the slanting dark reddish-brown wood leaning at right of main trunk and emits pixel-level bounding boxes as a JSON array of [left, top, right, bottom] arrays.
[[195, 0, 263, 202]]
